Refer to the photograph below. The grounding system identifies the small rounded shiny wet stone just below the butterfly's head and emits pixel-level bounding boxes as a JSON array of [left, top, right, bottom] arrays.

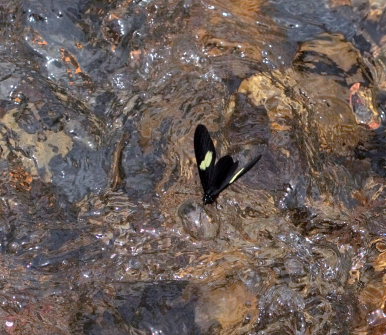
[[178, 200, 220, 240]]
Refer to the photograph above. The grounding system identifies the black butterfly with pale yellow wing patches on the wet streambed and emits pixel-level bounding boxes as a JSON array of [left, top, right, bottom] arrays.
[[194, 124, 261, 205]]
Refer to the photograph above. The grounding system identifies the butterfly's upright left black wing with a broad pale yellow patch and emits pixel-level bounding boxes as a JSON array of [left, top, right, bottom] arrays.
[[194, 124, 216, 193]]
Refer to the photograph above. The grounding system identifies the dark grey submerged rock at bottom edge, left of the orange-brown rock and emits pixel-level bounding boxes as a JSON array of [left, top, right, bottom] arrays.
[[80, 281, 201, 335]]
